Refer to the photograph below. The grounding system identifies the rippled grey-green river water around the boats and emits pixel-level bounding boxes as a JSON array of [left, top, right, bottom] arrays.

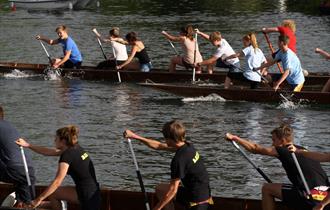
[[0, 0, 330, 198]]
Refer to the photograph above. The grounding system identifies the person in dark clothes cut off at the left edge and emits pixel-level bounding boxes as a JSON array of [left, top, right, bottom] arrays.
[[0, 106, 35, 208]]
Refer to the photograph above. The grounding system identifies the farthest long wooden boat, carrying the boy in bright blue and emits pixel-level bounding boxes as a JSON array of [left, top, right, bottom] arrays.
[[0, 62, 330, 86]]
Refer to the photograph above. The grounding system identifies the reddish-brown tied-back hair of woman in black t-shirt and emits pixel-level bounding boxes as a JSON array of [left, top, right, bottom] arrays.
[[56, 125, 79, 147]]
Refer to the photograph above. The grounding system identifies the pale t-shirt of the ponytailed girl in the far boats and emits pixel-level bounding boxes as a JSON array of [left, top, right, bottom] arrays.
[[242, 45, 266, 82]]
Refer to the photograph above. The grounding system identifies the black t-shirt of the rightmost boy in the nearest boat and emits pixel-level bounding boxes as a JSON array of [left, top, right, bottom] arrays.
[[276, 145, 329, 190]]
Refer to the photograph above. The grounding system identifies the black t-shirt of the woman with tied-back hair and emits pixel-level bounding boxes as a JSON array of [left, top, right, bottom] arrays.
[[59, 144, 99, 200]]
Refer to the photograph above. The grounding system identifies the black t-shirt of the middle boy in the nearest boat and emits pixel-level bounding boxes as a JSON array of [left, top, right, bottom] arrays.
[[171, 142, 210, 202]]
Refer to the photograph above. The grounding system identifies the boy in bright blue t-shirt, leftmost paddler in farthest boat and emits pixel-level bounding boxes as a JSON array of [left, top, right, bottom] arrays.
[[36, 25, 82, 68]]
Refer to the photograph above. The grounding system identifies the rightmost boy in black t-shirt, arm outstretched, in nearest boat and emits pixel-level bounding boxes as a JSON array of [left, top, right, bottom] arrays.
[[226, 125, 329, 210]]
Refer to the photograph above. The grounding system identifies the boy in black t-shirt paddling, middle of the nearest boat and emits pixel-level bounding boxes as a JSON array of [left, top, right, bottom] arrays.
[[124, 120, 213, 210]]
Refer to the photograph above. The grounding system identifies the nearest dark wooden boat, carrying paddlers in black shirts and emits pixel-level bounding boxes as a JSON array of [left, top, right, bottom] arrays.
[[0, 183, 289, 210]]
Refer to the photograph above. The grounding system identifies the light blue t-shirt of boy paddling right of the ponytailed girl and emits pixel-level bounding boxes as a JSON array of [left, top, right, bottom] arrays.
[[275, 49, 305, 85]]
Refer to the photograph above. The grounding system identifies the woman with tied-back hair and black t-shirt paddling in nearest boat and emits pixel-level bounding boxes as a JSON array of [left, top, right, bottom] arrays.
[[16, 125, 101, 210]]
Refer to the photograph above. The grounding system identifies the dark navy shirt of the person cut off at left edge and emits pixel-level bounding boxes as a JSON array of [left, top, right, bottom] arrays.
[[0, 120, 32, 167]]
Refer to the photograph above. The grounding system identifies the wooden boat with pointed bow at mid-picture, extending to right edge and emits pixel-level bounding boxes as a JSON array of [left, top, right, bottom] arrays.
[[140, 83, 330, 104]]
